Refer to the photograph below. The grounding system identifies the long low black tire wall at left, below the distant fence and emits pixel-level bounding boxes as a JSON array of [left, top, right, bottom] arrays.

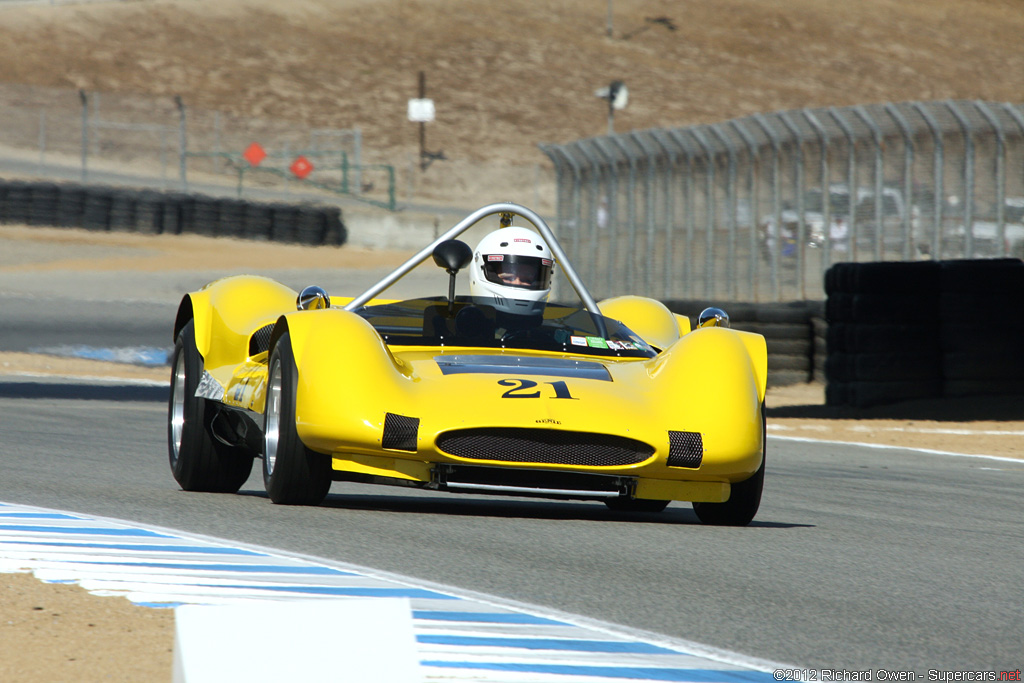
[[0, 179, 348, 246]]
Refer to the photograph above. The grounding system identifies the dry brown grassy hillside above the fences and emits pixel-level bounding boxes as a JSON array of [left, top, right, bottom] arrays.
[[0, 0, 1024, 171]]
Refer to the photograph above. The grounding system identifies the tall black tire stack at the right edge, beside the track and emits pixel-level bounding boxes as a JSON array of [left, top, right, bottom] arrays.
[[824, 259, 1024, 408]]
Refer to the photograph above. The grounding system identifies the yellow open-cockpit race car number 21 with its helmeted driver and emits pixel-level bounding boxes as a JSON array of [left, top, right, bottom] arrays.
[[168, 203, 767, 524]]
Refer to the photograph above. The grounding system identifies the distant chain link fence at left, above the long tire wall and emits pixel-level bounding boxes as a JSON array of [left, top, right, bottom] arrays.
[[0, 84, 395, 209]]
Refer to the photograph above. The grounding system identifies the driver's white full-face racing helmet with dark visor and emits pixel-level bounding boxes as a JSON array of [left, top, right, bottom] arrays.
[[469, 226, 555, 315]]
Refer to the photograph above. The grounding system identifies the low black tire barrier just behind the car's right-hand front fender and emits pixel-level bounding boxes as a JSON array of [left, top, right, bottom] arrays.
[[664, 300, 825, 387]]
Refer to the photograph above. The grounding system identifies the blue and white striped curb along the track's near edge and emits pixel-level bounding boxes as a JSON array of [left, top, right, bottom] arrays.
[[0, 503, 779, 683]]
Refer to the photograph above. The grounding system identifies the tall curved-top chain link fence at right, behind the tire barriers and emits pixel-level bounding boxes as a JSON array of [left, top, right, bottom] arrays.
[[541, 101, 1024, 301]]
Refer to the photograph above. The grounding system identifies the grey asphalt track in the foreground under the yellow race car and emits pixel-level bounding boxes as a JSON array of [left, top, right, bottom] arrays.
[[0, 370, 1024, 673]]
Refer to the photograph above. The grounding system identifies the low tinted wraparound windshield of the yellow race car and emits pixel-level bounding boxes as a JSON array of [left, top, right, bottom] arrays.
[[354, 296, 655, 358]]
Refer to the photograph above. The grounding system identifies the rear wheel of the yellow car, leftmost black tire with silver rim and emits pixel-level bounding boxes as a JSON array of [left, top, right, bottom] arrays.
[[167, 321, 253, 494]]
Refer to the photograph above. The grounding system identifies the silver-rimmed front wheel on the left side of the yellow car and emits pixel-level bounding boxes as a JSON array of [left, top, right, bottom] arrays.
[[263, 332, 331, 505]]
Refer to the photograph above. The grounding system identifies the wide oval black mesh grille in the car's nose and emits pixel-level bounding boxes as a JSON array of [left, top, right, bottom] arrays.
[[437, 428, 654, 467]]
